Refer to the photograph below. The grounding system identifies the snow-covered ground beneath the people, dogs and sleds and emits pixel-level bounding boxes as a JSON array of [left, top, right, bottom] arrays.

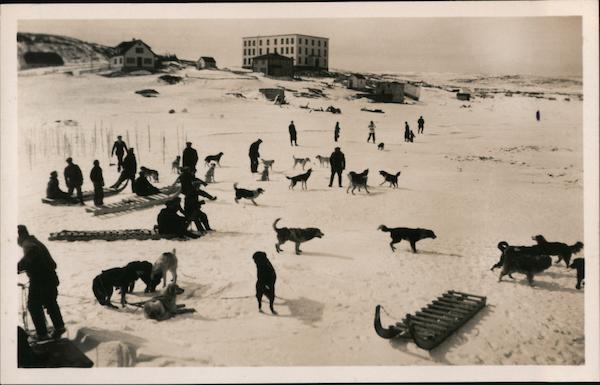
[[18, 69, 585, 366]]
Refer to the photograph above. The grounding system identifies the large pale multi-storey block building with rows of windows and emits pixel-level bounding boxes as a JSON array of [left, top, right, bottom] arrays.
[[242, 34, 329, 70]]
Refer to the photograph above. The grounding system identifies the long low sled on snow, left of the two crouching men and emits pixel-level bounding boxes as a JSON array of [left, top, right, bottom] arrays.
[[48, 229, 202, 242]]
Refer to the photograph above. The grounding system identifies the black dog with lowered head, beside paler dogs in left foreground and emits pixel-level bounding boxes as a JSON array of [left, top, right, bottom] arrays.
[[92, 261, 160, 308]]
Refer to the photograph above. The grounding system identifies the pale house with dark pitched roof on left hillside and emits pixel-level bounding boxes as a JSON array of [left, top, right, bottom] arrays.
[[109, 39, 157, 70]]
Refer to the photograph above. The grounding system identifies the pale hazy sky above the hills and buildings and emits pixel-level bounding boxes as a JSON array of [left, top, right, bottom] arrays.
[[18, 16, 582, 76]]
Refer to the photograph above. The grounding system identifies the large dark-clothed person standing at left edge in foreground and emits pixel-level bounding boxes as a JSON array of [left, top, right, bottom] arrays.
[[17, 225, 66, 340]]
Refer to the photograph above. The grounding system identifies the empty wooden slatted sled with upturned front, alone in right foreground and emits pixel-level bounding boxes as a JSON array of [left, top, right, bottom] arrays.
[[373, 290, 486, 350]]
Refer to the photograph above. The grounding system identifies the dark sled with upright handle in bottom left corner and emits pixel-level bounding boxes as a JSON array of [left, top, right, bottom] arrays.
[[17, 284, 94, 368]]
